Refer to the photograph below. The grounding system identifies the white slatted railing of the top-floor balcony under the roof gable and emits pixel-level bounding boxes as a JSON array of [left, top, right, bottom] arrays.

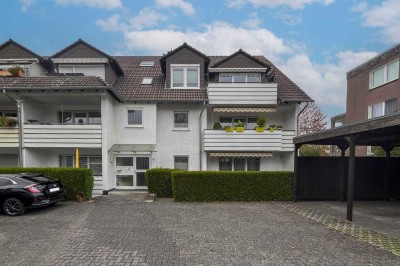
[[208, 83, 278, 106]]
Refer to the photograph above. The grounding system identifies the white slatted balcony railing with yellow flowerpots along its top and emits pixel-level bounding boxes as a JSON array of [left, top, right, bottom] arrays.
[[203, 130, 295, 152]]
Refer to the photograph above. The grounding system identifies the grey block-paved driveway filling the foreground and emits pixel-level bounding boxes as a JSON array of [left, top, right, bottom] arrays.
[[0, 195, 400, 265]]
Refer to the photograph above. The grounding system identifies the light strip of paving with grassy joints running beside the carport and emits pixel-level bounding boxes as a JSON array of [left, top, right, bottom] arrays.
[[278, 202, 400, 256]]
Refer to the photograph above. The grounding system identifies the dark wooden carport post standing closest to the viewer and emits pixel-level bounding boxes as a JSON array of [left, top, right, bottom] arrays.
[[346, 134, 357, 222]]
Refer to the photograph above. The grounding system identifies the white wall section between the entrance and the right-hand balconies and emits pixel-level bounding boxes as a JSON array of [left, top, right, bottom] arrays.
[[158, 103, 206, 170]]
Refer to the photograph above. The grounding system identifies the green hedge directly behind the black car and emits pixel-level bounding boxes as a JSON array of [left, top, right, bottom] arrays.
[[0, 167, 94, 200]]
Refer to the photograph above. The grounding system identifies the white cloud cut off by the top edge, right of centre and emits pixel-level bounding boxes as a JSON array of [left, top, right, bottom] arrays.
[[226, 0, 335, 9]]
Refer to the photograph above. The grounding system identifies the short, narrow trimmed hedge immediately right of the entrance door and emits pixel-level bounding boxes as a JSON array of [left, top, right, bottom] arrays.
[[146, 168, 179, 198]]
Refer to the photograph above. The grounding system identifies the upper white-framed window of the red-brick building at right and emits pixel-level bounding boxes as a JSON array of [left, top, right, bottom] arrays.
[[370, 59, 399, 89]]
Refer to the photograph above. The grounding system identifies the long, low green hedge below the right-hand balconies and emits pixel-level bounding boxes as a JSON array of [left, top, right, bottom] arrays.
[[172, 171, 294, 201]]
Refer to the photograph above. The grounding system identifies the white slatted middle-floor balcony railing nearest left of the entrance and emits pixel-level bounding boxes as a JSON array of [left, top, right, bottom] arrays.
[[24, 125, 102, 148]]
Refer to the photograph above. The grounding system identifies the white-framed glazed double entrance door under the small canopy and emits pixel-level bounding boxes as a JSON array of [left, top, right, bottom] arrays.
[[115, 156, 150, 189]]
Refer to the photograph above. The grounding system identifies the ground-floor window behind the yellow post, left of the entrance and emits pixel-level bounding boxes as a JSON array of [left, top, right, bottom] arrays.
[[60, 155, 103, 176]]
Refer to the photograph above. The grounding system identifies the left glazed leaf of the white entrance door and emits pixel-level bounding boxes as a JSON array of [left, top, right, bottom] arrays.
[[115, 156, 135, 189]]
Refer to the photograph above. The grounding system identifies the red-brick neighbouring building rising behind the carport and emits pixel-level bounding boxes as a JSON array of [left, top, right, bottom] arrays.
[[333, 44, 400, 156]]
